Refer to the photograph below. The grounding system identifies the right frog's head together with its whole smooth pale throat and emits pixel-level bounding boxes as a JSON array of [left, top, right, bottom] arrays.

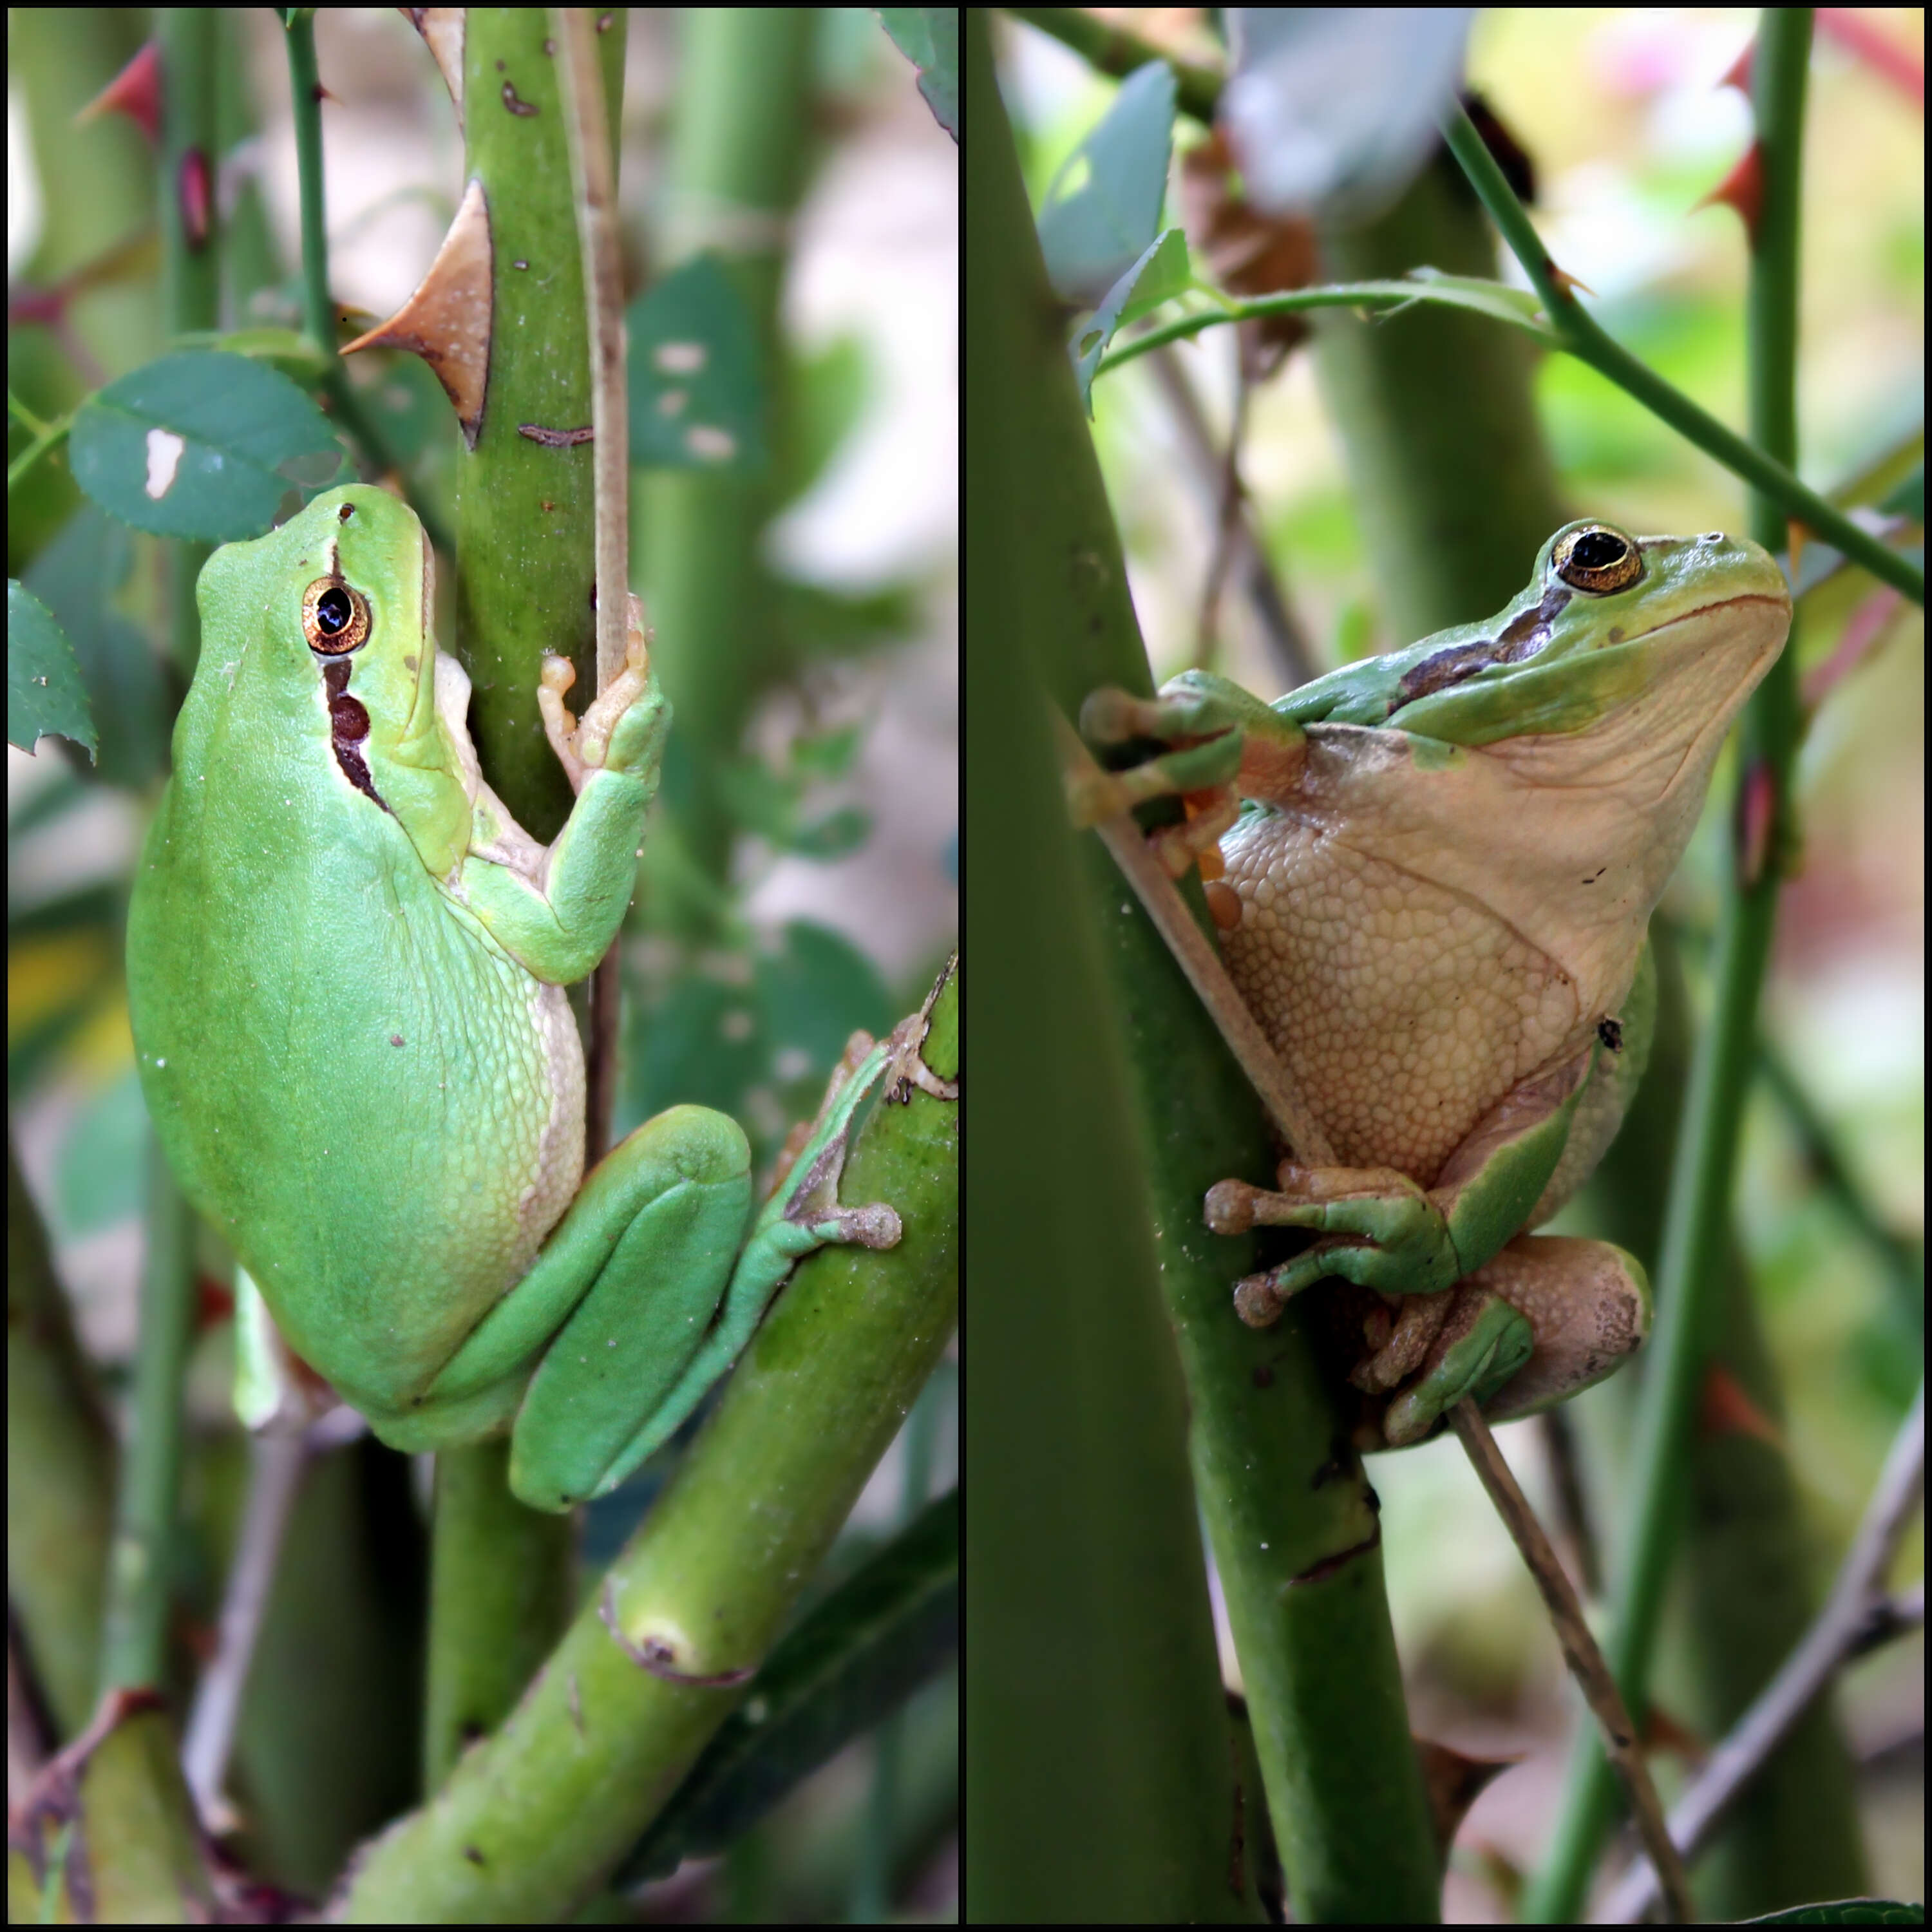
[[1283, 522, 1791, 980]]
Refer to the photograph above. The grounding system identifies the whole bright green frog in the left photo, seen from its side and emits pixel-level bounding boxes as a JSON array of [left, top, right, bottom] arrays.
[[128, 487, 898, 1509]]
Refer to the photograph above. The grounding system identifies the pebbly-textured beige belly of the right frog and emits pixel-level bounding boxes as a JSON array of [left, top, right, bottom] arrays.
[[1221, 810, 1588, 1186]]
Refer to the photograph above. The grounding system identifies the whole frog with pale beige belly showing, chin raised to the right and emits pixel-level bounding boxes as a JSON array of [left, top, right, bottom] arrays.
[[1082, 522, 1791, 1447]]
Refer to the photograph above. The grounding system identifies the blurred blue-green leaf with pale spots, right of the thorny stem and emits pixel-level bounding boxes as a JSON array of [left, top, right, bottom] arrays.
[[628, 255, 767, 475]]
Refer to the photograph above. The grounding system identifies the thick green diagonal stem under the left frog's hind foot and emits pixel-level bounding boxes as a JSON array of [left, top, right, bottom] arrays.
[[338, 974, 958, 1924]]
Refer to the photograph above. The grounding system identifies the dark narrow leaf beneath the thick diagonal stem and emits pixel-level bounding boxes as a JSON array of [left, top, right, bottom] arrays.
[[618, 1490, 960, 1884]]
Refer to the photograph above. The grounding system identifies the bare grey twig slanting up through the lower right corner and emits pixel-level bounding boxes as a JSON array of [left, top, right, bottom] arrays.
[[1602, 1381, 1926, 1924]]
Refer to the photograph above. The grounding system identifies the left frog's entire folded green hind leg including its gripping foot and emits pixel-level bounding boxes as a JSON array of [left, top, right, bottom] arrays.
[[415, 1047, 898, 1509]]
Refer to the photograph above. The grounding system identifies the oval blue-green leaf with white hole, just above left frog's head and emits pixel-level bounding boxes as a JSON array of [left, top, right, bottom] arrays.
[[71, 350, 342, 543]]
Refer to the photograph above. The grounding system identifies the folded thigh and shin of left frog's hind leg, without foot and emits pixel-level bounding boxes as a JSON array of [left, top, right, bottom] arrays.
[[491, 1107, 752, 1509]]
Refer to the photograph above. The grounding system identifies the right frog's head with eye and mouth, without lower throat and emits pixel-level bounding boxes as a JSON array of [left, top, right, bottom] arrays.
[[1387, 522, 1791, 784]]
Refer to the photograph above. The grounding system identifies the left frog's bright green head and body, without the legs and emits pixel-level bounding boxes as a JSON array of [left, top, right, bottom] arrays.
[[128, 489, 603, 1408]]
